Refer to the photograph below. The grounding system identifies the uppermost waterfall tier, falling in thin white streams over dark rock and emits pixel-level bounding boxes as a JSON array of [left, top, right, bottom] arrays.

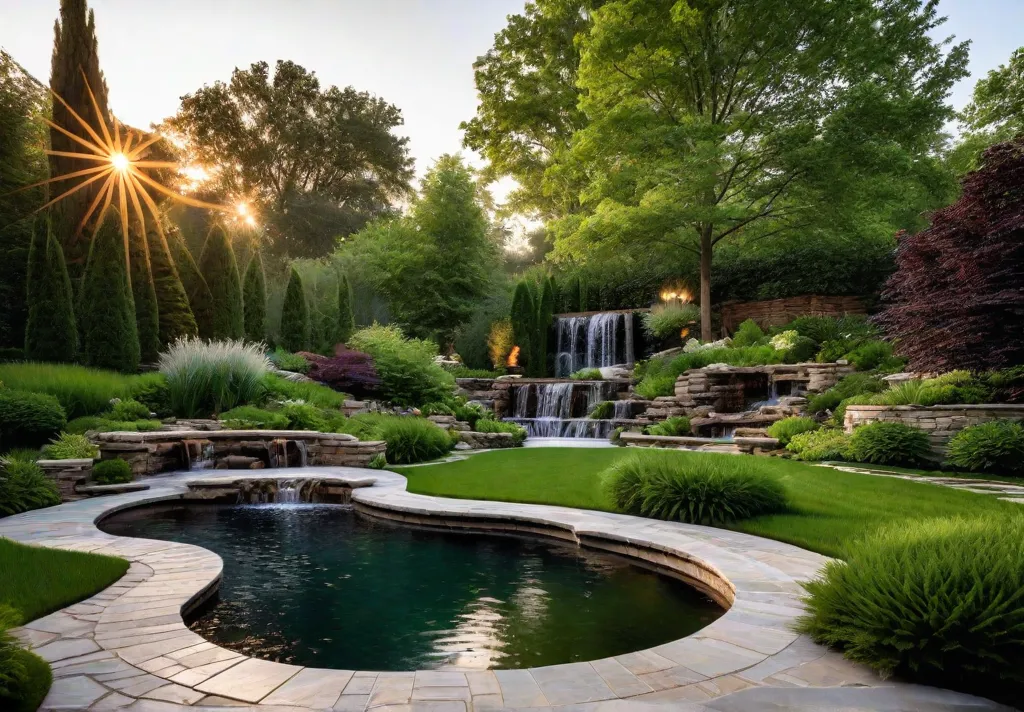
[[555, 311, 635, 378]]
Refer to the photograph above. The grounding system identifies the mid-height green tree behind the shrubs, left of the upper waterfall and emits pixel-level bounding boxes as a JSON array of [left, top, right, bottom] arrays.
[[351, 156, 498, 346]]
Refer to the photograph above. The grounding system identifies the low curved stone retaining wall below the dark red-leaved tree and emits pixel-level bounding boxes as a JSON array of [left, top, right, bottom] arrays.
[[843, 404, 1024, 460]]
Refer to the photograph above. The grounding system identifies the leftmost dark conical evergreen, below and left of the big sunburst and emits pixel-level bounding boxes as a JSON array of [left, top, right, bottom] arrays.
[[25, 216, 78, 362]]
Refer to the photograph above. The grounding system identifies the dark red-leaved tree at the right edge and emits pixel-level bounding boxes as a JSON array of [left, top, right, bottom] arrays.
[[877, 135, 1024, 371]]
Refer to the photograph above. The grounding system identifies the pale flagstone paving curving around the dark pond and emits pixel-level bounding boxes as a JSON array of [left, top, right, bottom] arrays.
[[0, 467, 1005, 712]]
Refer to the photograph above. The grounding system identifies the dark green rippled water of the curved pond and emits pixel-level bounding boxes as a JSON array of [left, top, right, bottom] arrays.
[[101, 505, 723, 670]]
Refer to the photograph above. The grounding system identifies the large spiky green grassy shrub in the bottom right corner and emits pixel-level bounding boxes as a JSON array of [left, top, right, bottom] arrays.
[[799, 516, 1024, 701]]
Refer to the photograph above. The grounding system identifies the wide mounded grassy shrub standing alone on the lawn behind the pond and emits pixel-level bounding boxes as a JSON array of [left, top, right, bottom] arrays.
[[602, 451, 786, 526]]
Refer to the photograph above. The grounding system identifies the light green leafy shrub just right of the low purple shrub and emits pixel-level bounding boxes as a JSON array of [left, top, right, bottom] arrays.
[[348, 325, 455, 407]]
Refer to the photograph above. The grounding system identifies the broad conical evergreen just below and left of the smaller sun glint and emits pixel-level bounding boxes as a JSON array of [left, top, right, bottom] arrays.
[[199, 225, 245, 339]]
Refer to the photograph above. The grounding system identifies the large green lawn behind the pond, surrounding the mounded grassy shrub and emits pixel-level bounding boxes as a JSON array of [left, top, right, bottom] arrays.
[[393, 448, 1024, 556]]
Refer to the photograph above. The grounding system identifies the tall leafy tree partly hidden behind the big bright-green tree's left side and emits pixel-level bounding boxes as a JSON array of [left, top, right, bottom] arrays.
[[461, 0, 601, 219]]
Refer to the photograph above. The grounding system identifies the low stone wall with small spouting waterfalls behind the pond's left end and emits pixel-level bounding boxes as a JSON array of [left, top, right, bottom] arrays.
[[93, 430, 386, 476]]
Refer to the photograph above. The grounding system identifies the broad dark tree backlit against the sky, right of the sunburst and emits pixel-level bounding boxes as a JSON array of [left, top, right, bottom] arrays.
[[167, 61, 413, 257]]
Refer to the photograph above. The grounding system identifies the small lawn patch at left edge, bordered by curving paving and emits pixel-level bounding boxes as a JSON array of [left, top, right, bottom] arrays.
[[0, 538, 128, 623]]
